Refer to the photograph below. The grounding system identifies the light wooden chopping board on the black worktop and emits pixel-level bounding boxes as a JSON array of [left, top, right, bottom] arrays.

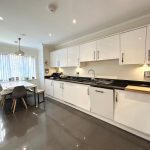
[[125, 85, 150, 94]]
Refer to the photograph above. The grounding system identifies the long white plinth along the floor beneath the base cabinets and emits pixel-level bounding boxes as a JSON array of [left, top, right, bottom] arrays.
[[45, 94, 150, 141]]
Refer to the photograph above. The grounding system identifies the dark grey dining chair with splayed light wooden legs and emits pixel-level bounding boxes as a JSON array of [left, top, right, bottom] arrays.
[[12, 86, 27, 113]]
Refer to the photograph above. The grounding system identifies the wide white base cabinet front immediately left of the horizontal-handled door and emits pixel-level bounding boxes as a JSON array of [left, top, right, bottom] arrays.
[[63, 82, 90, 111]]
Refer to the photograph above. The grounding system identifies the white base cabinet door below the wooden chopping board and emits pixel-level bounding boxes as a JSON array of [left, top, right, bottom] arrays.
[[114, 90, 150, 134]]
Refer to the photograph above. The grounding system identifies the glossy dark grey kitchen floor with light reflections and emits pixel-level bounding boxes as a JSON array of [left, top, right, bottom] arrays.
[[0, 99, 150, 150]]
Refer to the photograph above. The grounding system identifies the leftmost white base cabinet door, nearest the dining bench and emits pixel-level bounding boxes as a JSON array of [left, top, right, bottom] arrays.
[[45, 79, 54, 96]]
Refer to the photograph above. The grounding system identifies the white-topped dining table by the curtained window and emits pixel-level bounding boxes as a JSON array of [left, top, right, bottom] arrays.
[[0, 81, 37, 107]]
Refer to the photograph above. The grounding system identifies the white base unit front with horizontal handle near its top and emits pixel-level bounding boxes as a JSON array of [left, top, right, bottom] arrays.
[[90, 87, 114, 120]]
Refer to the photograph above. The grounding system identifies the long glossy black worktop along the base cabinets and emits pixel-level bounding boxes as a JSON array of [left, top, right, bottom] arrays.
[[45, 76, 150, 90]]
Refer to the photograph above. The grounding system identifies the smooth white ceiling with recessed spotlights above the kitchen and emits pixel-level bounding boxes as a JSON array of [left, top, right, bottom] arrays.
[[0, 0, 150, 48]]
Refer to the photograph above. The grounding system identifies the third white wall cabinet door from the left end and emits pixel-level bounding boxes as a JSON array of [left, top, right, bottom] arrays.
[[68, 46, 79, 67]]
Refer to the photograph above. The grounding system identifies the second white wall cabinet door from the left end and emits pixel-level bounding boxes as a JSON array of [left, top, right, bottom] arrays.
[[59, 48, 67, 67]]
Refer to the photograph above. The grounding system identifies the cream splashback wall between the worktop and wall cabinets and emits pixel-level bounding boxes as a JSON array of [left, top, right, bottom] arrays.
[[59, 60, 150, 81]]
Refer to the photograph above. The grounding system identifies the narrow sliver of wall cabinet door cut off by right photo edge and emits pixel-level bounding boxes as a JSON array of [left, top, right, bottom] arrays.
[[146, 26, 150, 64]]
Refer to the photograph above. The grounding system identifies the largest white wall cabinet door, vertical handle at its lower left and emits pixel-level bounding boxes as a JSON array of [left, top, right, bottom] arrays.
[[120, 28, 146, 64]]
